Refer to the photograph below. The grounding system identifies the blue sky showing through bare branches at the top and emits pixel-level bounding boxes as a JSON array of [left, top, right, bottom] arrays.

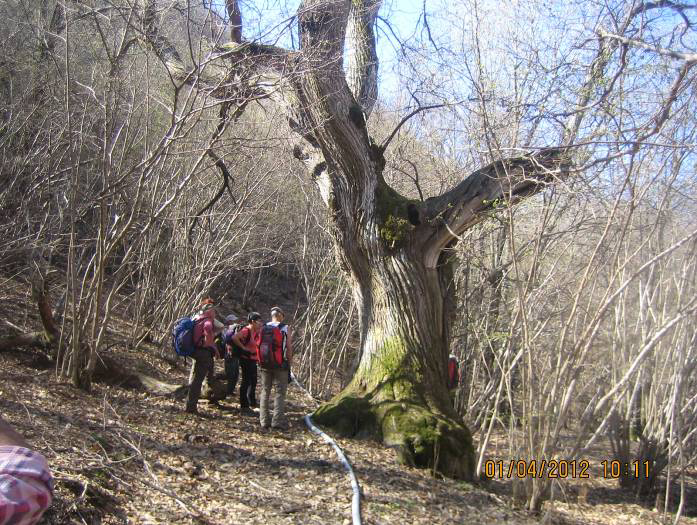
[[218, 0, 697, 171]]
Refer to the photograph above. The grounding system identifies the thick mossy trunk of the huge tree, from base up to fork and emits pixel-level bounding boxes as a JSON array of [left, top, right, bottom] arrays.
[[315, 240, 475, 479]]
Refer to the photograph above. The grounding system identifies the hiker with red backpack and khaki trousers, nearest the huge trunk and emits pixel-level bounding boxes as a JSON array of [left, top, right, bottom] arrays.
[[258, 306, 293, 429]]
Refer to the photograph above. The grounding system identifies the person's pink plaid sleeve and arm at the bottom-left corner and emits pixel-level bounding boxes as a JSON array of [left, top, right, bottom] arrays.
[[0, 417, 53, 525]]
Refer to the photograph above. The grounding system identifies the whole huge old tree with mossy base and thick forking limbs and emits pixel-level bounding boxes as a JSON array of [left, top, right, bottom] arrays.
[[144, 0, 564, 479]]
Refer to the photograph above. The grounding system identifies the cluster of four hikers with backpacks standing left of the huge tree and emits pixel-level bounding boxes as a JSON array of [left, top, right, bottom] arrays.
[[177, 299, 293, 429]]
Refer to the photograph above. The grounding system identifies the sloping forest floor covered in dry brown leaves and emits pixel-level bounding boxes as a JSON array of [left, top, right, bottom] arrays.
[[0, 278, 697, 525]]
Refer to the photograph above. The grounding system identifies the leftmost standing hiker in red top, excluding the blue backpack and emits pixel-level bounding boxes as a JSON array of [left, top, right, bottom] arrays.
[[186, 299, 223, 414]]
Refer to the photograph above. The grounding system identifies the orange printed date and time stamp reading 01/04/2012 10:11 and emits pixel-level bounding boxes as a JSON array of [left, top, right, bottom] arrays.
[[484, 459, 650, 479]]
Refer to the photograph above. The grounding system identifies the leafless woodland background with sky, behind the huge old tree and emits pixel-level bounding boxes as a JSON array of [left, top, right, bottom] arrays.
[[0, 0, 697, 514]]
